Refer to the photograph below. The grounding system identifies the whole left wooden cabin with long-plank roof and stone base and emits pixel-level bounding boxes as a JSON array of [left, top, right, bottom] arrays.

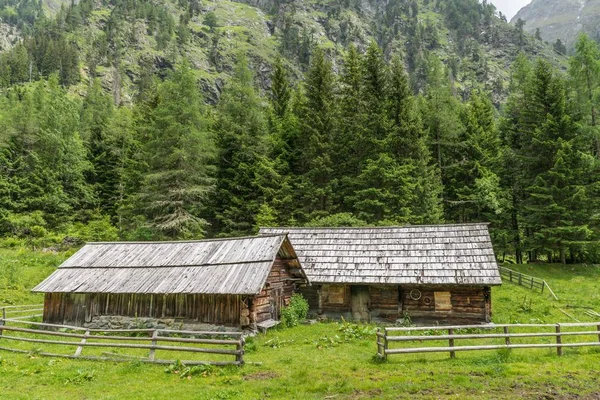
[[33, 234, 306, 328]]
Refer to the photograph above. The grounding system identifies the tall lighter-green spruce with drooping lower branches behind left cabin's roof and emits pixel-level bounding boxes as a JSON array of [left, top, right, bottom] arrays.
[[138, 61, 213, 238]]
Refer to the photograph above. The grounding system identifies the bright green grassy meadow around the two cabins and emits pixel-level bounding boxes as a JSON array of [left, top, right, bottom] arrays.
[[0, 249, 600, 399]]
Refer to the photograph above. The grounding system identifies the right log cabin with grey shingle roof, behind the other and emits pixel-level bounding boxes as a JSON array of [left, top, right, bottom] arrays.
[[261, 223, 502, 324]]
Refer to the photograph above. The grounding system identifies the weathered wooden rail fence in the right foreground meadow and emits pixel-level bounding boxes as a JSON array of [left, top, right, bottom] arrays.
[[377, 322, 600, 359]]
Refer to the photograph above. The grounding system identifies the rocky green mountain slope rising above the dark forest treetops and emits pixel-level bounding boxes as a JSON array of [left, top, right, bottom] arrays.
[[0, 0, 564, 103]]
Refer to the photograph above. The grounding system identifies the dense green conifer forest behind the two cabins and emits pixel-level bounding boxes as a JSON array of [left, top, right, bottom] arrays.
[[0, 0, 600, 263]]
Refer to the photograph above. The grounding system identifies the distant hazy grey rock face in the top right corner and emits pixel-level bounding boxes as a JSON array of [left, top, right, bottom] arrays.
[[510, 0, 600, 48]]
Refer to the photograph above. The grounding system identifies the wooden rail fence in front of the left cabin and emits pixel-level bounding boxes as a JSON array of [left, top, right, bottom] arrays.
[[0, 318, 245, 365]]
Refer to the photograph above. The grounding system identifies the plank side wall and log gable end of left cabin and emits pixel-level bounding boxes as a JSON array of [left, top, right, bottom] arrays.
[[44, 258, 296, 326]]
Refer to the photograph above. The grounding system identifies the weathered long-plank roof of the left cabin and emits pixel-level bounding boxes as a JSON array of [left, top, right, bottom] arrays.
[[33, 234, 296, 294]]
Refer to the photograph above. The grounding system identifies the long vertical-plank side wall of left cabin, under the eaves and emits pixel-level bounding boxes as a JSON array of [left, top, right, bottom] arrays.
[[44, 293, 244, 326]]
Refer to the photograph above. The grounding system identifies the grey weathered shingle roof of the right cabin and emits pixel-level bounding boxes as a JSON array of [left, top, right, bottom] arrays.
[[260, 224, 502, 285]]
